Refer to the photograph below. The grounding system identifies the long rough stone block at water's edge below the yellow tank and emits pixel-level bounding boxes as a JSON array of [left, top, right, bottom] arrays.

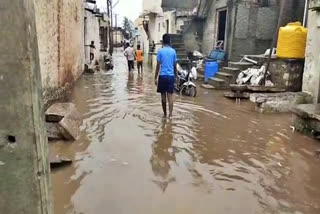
[[250, 92, 312, 112]]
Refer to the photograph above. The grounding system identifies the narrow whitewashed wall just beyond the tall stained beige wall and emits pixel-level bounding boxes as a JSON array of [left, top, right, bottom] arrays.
[[82, 11, 101, 64]]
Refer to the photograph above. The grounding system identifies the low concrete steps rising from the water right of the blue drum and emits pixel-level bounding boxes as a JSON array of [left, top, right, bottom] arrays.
[[208, 62, 253, 90]]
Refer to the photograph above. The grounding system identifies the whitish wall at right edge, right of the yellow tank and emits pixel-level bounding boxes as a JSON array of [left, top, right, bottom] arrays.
[[303, 11, 320, 103]]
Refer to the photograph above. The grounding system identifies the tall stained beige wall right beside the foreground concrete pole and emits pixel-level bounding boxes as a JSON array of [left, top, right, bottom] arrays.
[[35, 0, 84, 105]]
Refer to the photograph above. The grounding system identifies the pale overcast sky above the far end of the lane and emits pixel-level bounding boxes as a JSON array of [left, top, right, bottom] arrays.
[[97, 0, 142, 22]]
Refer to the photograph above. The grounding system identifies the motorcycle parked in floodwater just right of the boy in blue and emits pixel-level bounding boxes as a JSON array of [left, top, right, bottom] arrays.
[[175, 65, 197, 97]]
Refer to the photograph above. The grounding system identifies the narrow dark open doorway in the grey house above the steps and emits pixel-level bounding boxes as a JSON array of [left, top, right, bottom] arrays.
[[216, 9, 227, 50]]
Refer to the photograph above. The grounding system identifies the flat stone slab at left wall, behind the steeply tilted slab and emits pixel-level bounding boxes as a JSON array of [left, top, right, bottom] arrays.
[[46, 103, 76, 123]]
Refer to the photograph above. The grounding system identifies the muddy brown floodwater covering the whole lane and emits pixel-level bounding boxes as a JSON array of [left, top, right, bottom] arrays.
[[51, 50, 320, 214]]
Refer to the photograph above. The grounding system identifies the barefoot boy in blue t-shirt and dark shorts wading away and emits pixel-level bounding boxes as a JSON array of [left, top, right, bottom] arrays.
[[155, 34, 177, 118]]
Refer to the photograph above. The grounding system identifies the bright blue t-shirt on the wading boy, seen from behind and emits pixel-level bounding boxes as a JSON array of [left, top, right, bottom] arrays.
[[157, 46, 177, 76]]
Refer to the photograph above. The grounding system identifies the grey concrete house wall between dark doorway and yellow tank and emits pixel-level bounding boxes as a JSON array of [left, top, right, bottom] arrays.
[[228, 3, 279, 60]]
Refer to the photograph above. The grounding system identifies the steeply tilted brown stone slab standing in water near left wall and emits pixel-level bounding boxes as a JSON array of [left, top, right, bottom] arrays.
[[58, 105, 82, 140]]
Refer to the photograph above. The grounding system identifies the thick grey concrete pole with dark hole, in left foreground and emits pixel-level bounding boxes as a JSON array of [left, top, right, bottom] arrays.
[[0, 0, 53, 214]]
